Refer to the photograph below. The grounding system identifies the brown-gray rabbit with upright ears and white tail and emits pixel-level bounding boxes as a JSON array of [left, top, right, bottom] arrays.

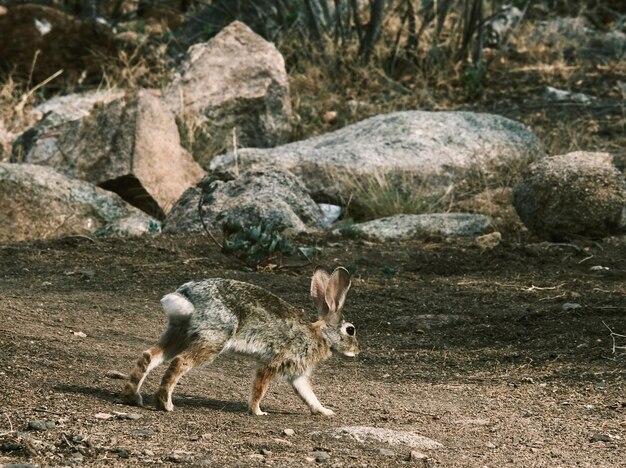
[[122, 267, 359, 416]]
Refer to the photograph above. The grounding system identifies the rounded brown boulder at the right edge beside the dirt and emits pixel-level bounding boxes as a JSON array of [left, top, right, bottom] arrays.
[[513, 151, 626, 241]]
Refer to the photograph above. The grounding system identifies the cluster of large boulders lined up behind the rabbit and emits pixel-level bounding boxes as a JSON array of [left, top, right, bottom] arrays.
[[0, 18, 626, 245]]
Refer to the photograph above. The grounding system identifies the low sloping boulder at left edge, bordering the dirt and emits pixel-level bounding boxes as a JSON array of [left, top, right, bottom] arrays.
[[0, 163, 159, 241]]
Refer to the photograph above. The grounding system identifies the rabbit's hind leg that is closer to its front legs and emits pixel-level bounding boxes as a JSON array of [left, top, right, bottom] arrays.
[[154, 340, 226, 411]]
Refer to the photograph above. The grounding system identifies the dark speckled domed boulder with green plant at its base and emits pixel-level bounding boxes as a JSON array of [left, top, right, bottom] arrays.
[[163, 169, 323, 232]]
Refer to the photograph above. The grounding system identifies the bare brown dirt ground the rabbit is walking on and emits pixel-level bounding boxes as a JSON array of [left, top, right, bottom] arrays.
[[0, 232, 626, 467]]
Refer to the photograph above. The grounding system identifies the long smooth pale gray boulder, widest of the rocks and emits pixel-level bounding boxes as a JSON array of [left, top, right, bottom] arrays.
[[209, 111, 543, 206]]
